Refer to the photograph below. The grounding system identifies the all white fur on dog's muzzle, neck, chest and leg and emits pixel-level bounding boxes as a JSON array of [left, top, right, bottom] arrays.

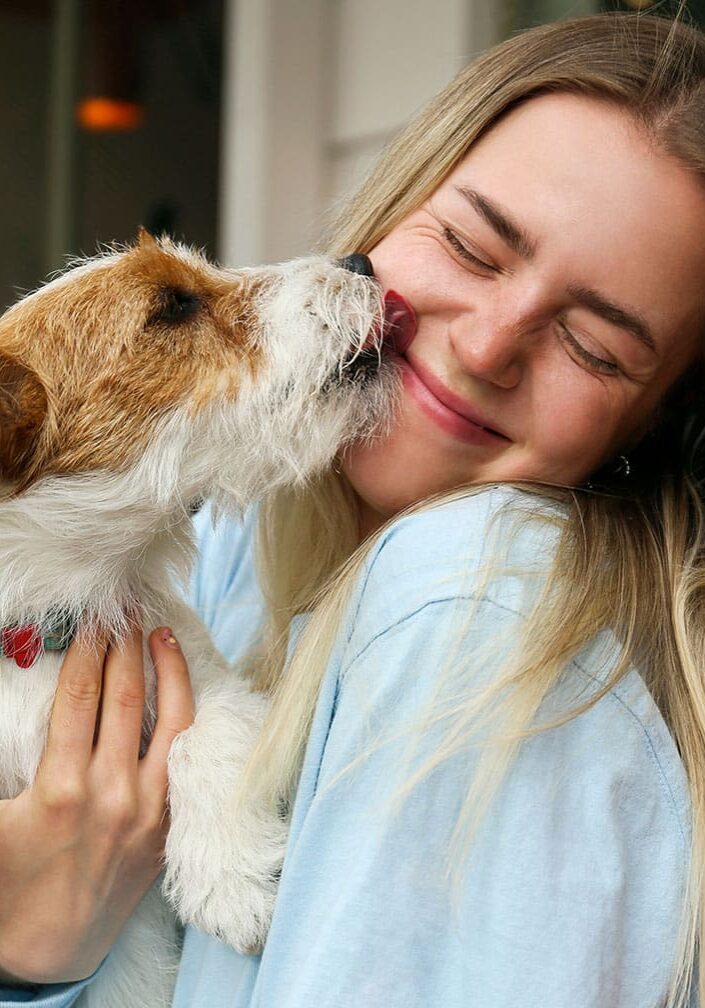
[[0, 251, 398, 1008]]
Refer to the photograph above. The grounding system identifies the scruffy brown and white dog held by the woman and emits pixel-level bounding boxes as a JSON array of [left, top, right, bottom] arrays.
[[0, 233, 398, 1008]]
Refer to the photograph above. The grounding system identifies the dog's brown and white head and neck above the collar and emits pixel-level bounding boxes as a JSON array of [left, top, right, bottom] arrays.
[[0, 232, 399, 632]]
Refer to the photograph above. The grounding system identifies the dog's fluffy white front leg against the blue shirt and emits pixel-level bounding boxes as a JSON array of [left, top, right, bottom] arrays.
[[164, 614, 286, 951]]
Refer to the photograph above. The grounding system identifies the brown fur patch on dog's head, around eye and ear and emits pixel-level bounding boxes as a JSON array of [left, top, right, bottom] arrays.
[[0, 232, 263, 488]]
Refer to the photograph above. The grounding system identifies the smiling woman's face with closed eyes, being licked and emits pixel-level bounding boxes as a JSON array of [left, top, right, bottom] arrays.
[[343, 94, 705, 531]]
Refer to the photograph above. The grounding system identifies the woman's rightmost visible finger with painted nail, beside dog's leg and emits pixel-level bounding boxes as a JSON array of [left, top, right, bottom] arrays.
[[142, 627, 194, 792]]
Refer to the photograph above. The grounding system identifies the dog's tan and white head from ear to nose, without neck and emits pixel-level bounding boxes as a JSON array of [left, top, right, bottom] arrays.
[[0, 233, 397, 508]]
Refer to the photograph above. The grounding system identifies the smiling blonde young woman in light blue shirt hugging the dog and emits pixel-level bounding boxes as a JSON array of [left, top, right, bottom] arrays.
[[0, 9, 705, 1008]]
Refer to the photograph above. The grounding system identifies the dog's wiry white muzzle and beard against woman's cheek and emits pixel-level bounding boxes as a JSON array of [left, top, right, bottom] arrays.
[[184, 259, 400, 506]]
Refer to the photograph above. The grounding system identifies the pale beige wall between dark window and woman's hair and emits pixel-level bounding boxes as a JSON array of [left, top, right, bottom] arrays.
[[219, 0, 498, 265]]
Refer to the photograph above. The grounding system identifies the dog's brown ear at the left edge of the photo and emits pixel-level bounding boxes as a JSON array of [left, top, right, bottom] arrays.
[[0, 352, 47, 483]]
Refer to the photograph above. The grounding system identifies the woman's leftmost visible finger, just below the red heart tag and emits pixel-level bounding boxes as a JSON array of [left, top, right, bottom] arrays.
[[44, 631, 107, 772]]
